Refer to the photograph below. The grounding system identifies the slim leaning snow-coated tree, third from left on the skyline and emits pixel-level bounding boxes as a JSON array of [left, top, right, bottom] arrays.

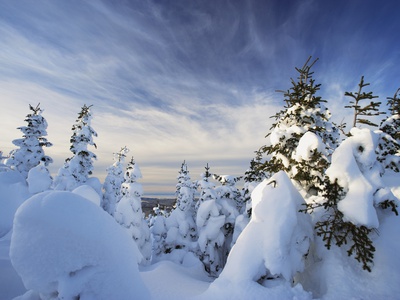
[[101, 147, 129, 215]]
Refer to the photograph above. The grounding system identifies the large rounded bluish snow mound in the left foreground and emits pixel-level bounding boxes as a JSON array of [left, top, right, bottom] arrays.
[[10, 191, 149, 300]]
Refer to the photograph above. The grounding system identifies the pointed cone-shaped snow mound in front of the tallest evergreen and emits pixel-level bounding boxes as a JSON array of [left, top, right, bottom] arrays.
[[207, 171, 313, 299]]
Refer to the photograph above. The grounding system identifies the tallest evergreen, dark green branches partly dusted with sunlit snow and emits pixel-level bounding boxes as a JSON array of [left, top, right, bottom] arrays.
[[260, 57, 339, 193]]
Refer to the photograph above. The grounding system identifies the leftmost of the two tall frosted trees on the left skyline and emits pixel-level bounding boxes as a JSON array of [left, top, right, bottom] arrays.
[[5, 103, 53, 178]]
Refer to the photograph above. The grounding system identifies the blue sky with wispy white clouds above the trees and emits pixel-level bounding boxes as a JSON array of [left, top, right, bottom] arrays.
[[0, 0, 400, 195]]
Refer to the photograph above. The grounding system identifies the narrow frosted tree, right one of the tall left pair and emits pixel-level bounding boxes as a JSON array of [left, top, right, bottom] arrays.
[[54, 104, 97, 190]]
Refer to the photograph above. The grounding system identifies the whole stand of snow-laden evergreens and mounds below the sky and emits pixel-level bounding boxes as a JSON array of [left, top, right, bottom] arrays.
[[0, 57, 400, 299]]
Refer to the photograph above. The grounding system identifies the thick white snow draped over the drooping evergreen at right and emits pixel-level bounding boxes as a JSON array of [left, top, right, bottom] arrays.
[[326, 128, 393, 228]]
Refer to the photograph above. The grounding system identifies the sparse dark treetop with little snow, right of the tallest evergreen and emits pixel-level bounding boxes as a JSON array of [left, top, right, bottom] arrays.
[[344, 76, 384, 127]]
